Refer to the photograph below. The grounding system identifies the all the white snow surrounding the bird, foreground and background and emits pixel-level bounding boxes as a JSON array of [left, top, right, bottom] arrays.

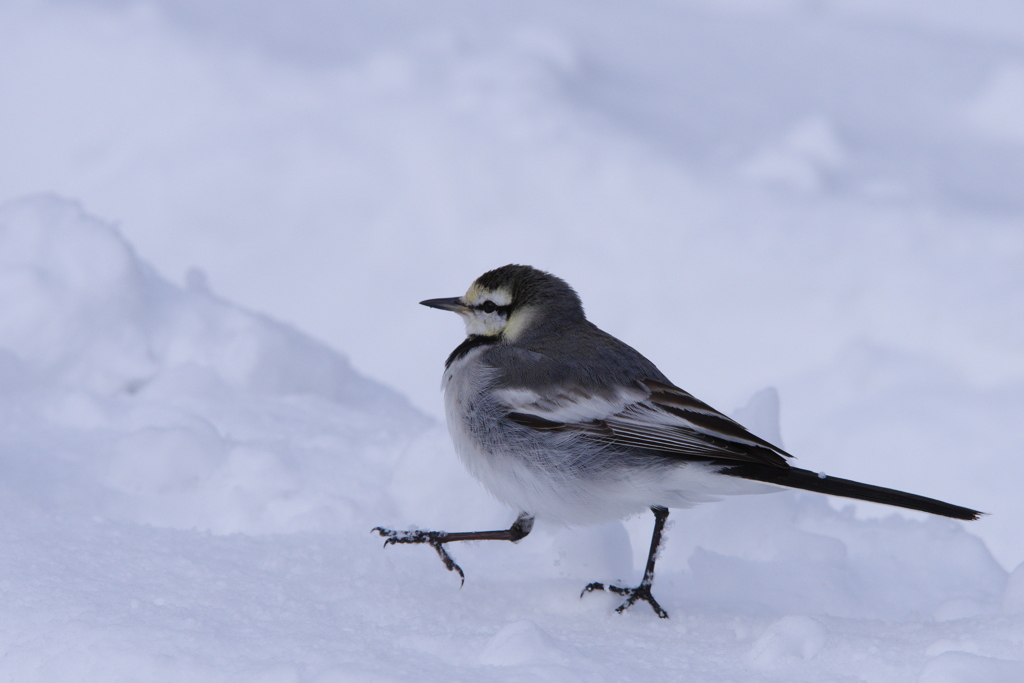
[[0, 0, 1024, 683]]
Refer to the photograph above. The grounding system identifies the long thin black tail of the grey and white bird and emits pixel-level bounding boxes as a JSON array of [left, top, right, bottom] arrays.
[[720, 463, 985, 520]]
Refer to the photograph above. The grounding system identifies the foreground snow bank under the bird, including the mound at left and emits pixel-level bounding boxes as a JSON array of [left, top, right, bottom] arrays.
[[0, 196, 1022, 683]]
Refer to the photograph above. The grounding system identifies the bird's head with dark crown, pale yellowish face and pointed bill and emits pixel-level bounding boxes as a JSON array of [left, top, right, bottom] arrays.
[[420, 264, 586, 342]]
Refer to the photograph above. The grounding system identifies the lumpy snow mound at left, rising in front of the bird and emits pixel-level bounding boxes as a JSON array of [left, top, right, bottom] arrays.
[[0, 196, 431, 532]]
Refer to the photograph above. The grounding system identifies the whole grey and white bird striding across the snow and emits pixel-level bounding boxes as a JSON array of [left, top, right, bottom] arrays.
[[374, 265, 982, 617]]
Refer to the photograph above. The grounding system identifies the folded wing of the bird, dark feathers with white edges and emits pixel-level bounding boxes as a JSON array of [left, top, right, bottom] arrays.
[[498, 380, 792, 467]]
